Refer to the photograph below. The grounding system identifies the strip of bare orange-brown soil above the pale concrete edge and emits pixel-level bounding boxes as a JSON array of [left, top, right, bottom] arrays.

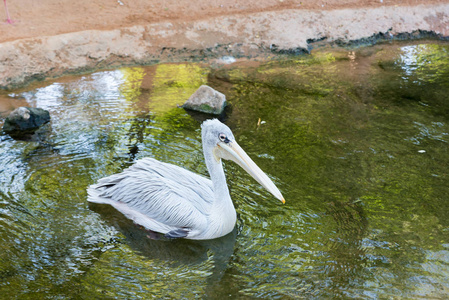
[[0, 0, 448, 43]]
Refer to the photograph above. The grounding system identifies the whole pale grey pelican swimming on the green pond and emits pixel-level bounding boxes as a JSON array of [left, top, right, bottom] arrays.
[[87, 119, 285, 240]]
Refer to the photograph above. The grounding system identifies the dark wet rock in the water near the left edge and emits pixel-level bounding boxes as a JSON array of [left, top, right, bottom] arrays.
[[3, 107, 50, 135]]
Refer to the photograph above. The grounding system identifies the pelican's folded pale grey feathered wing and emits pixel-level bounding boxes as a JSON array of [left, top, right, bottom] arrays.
[[87, 158, 214, 236]]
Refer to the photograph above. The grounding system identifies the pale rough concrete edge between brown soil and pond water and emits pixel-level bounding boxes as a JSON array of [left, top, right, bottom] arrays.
[[0, 3, 449, 89]]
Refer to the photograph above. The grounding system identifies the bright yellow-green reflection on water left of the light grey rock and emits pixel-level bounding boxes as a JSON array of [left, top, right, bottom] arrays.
[[121, 64, 206, 158]]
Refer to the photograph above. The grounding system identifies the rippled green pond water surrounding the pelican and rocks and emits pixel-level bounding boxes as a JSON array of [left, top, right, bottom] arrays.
[[0, 42, 449, 299]]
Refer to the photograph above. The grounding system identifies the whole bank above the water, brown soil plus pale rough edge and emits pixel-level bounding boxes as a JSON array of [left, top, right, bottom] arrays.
[[0, 0, 449, 88]]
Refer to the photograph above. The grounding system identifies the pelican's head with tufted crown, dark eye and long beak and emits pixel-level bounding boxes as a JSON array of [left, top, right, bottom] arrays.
[[201, 119, 285, 203]]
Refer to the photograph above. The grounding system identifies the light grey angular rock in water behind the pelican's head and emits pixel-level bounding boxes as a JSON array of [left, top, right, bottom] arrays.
[[182, 85, 226, 115]]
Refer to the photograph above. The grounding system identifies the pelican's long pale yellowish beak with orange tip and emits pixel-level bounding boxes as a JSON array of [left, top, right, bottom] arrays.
[[216, 141, 285, 203]]
